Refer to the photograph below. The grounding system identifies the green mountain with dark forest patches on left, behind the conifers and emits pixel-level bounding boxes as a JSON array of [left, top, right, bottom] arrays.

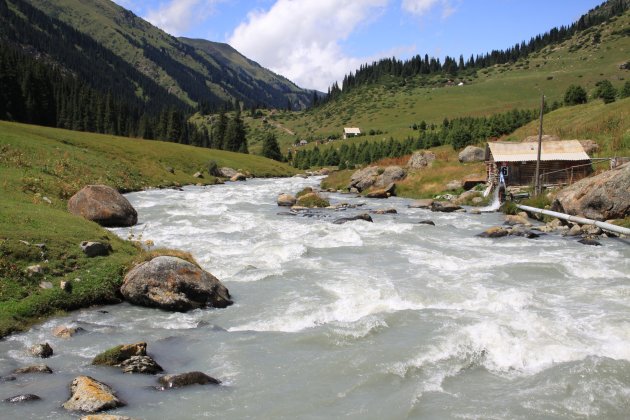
[[0, 0, 313, 108]]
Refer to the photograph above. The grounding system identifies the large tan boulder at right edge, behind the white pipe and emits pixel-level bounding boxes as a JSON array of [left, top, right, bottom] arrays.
[[551, 163, 630, 220]]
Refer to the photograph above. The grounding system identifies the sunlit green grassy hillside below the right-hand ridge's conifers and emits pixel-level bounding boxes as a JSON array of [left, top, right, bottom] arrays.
[[260, 4, 630, 155]]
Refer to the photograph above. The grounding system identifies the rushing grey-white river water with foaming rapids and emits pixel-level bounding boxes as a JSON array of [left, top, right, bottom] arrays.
[[0, 178, 630, 419]]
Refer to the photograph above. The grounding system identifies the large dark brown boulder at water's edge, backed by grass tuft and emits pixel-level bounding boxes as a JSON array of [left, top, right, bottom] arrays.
[[120, 256, 232, 312]]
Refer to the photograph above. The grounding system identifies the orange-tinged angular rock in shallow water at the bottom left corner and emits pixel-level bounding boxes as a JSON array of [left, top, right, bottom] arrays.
[[63, 376, 125, 413]]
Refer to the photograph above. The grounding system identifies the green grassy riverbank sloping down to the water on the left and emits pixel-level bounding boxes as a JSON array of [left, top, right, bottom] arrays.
[[0, 121, 295, 337]]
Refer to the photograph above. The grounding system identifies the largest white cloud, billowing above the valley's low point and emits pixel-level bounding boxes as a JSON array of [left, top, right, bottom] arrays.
[[228, 0, 389, 91]]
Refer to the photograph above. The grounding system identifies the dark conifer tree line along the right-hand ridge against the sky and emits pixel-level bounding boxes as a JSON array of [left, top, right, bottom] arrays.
[[324, 0, 630, 104]]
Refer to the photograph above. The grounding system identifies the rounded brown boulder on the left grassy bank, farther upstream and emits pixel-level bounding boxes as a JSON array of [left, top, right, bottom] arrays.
[[68, 185, 138, 227]]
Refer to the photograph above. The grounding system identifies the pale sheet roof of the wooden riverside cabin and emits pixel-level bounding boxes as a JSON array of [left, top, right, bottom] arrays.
[[488, 140, 590, 162]]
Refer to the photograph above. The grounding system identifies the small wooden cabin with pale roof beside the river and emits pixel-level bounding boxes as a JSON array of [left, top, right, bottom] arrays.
[[485, 140, 593, 186]]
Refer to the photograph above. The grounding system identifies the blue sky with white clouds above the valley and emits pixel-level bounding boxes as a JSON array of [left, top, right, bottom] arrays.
[[115, 0, 603, 92]]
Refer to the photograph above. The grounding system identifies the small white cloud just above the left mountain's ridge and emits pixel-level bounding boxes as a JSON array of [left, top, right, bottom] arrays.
[[145, 0, 217, 35]]
